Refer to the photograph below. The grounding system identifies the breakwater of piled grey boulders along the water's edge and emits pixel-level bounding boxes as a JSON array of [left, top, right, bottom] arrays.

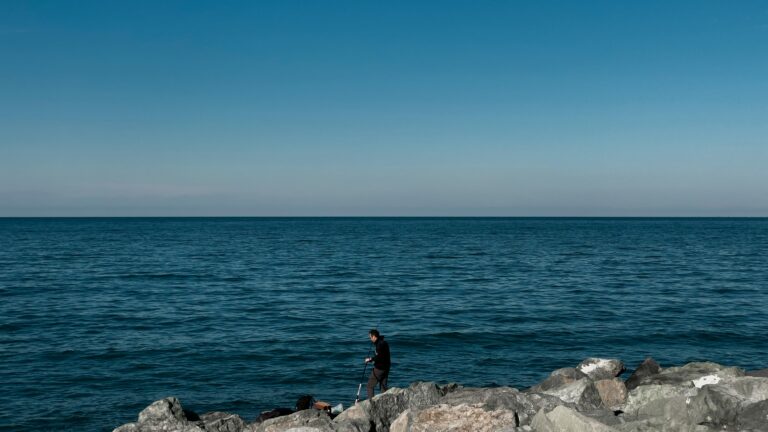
[[114, 358, 768, 432]]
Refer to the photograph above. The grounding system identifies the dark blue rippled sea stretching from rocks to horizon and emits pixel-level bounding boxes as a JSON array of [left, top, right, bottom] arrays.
[[0, 218, 768, 431]]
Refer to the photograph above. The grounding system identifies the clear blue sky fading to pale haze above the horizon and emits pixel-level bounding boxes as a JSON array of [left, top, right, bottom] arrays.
[[0, 0, 768, 216]]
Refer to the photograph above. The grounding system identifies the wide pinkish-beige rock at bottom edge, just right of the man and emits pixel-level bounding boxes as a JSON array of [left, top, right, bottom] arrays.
[[390, 404, 517, 432]]
